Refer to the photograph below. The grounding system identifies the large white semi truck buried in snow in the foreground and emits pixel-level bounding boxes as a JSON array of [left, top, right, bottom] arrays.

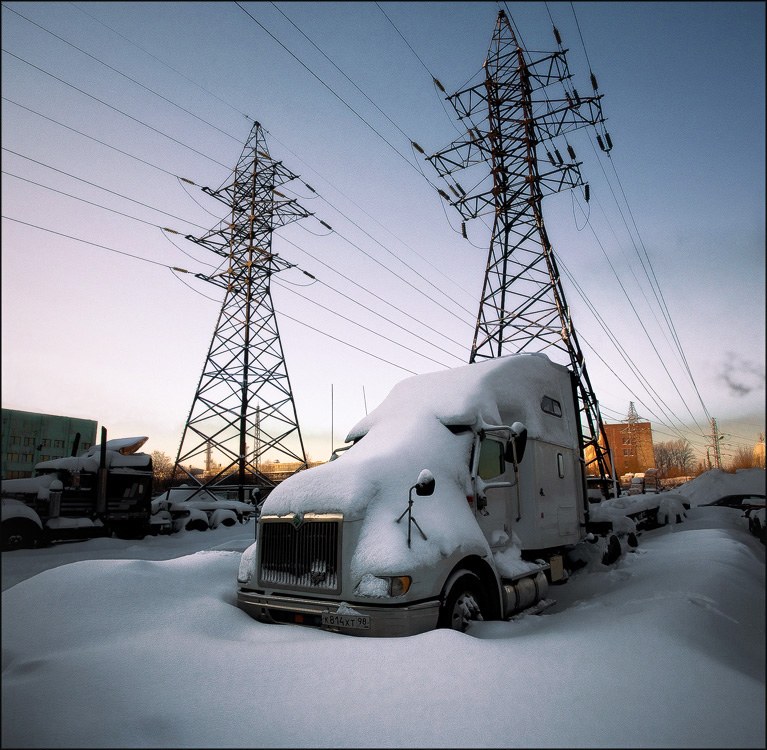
[[237, 354, 636, 636]]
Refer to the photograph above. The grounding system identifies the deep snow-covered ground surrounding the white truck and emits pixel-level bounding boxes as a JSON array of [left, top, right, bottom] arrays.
[[2, 470, 765, 747]]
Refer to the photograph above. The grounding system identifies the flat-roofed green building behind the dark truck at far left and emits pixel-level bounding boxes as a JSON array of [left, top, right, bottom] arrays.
[[0, 409, 98, 479]]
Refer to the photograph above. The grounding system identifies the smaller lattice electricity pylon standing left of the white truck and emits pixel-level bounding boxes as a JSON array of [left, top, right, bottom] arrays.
[[174, 122, 310, 501]]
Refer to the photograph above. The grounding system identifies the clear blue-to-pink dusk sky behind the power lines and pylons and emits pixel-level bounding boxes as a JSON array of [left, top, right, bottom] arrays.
[[2, 2, 765, 470]]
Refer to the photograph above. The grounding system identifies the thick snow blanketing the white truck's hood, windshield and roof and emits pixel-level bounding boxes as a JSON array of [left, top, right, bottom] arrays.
[[262, 355, 564, 575]]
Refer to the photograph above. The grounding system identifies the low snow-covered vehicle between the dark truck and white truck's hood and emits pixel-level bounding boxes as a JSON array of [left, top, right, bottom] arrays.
[[152, 485, 257, 531]]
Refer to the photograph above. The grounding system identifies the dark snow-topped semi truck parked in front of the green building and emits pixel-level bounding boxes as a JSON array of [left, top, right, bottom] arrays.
[[0, 431, 172, 550]]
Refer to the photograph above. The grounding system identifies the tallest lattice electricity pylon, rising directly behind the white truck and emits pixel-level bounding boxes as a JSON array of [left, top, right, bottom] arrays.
[[428, 10, 612, 479]]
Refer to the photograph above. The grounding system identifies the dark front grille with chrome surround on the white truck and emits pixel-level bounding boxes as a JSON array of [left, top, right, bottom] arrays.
[[258, 513, 343, 592]]
